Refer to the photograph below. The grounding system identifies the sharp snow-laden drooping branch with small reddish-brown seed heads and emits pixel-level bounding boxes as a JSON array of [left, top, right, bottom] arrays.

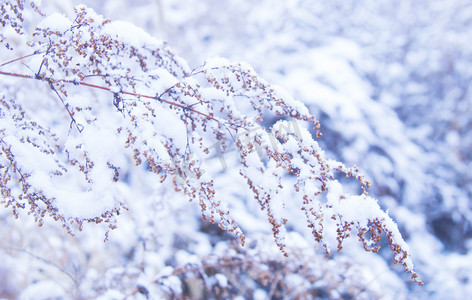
[[0, 1, 417, 281]]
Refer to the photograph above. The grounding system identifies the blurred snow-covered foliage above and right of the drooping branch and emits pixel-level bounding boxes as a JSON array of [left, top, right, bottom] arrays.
[[130, 0, 472, 299]]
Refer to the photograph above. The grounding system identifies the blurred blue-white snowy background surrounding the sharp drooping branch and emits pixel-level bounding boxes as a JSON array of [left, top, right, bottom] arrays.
[[0, 0, 472, 299]]
